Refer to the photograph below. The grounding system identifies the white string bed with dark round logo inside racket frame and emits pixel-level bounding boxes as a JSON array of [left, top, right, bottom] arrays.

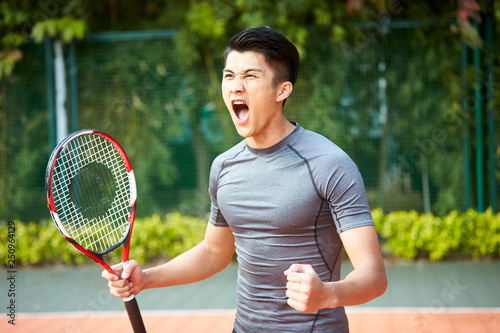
[[52, 134, 130, 252]]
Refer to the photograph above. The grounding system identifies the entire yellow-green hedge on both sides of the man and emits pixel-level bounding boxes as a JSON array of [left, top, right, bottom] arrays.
[[0, 209, 500, 265]]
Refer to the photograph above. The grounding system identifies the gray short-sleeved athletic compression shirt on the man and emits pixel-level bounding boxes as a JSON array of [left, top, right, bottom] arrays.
[[209, 124, 373, 333]]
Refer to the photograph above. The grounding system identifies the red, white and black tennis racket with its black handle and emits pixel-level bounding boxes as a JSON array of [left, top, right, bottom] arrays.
[[45, 130, 146, 333]]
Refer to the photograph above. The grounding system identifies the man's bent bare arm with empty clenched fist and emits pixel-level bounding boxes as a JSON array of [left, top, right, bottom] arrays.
[[285, 226, 387, 312]]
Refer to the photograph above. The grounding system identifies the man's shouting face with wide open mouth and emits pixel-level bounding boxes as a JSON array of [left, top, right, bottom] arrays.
[[222, 51, 288, 147]]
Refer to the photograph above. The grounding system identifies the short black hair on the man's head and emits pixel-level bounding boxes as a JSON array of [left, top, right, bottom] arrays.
[[223, 27, 299, 85]]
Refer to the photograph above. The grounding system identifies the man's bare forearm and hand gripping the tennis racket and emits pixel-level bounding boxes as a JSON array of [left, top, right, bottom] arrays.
[[102, 223, 235, 298]]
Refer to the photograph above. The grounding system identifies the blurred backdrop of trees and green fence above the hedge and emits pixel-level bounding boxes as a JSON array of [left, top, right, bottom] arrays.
[[0, 0, 500, 222]]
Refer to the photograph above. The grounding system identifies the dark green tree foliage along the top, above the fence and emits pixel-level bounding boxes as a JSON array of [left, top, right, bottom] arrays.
[[0, 0, 492, 84]]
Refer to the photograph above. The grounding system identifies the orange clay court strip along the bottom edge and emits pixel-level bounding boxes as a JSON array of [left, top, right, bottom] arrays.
[[1, 309, 500, 333]]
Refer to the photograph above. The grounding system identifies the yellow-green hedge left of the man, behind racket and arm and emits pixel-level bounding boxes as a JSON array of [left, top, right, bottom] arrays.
[[0, 212, 207, 266]]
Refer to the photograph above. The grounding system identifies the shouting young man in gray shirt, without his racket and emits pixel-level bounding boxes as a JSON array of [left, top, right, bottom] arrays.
[[102, 27, 387, 333]]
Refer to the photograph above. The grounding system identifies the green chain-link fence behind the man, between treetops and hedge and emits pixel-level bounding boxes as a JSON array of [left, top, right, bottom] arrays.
[[0, 26, 499, 220]]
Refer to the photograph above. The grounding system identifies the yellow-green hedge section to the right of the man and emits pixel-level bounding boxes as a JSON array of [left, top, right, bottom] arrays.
[[372, 209, 500, 260]]
